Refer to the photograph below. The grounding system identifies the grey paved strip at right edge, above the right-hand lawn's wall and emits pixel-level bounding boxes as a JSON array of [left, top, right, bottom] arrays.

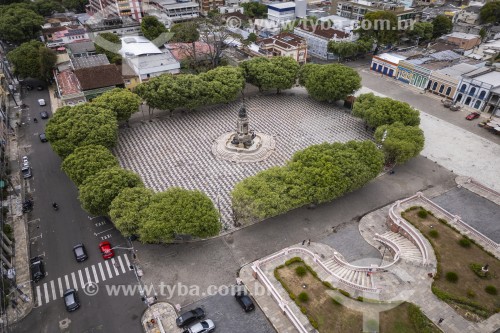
[[432, 187, 500, 243]]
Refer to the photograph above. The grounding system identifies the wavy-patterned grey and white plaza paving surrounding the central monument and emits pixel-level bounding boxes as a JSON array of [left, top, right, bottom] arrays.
[[114, 93, 372, 229]]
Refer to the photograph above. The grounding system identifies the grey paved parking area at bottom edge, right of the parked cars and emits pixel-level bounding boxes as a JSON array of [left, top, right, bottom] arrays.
[[181, 295, 276, 333]]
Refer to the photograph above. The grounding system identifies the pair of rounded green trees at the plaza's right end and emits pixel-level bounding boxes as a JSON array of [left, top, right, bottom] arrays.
[[353, 94, 425, 164]]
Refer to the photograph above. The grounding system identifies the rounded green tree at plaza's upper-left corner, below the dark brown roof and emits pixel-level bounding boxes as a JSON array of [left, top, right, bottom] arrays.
[[92, 88, 142, 122]]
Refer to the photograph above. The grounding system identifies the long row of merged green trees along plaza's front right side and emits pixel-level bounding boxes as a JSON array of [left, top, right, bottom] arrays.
[[231, 141, 384, 223]]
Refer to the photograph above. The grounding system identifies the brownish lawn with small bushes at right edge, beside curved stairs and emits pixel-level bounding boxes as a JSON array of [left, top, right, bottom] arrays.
[[402, 207, 500, 321]]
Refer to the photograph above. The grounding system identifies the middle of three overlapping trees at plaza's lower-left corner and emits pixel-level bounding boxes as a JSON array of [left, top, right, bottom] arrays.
[[109, 187, 154, 237]]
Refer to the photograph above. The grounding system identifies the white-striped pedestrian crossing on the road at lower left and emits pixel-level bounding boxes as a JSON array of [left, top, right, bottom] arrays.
[[36, 254, 130, 307]]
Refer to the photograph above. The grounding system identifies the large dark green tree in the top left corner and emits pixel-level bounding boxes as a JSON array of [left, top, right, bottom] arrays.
[[0, 5, 44, 43]]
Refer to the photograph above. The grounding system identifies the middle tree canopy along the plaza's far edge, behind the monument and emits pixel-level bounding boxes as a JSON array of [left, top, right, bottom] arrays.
[[240, 57, 299, 93]]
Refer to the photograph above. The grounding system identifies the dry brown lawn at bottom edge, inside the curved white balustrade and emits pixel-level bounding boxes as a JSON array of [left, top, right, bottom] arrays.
[[275, 262, 439, 333]]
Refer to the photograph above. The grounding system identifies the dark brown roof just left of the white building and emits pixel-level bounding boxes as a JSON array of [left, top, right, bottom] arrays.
[[75, 64, 124, 90]]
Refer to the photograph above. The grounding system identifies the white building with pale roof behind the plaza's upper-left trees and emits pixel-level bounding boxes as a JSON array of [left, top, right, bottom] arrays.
[[120, 36, 181, 82]]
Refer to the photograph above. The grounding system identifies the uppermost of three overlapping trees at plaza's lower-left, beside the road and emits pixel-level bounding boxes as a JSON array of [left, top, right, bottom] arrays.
[[79, 167, 144, 216]]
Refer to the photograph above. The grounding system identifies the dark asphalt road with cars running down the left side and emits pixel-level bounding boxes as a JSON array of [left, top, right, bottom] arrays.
[[12, 81, 145, 333]]
